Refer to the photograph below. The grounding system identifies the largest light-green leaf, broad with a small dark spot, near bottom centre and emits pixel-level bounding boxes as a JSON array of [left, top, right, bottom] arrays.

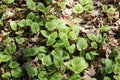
[[67, 57, 88, 74]]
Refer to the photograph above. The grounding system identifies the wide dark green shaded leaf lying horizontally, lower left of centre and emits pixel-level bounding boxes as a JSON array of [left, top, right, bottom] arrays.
[[22, 47, 39, 57]]
